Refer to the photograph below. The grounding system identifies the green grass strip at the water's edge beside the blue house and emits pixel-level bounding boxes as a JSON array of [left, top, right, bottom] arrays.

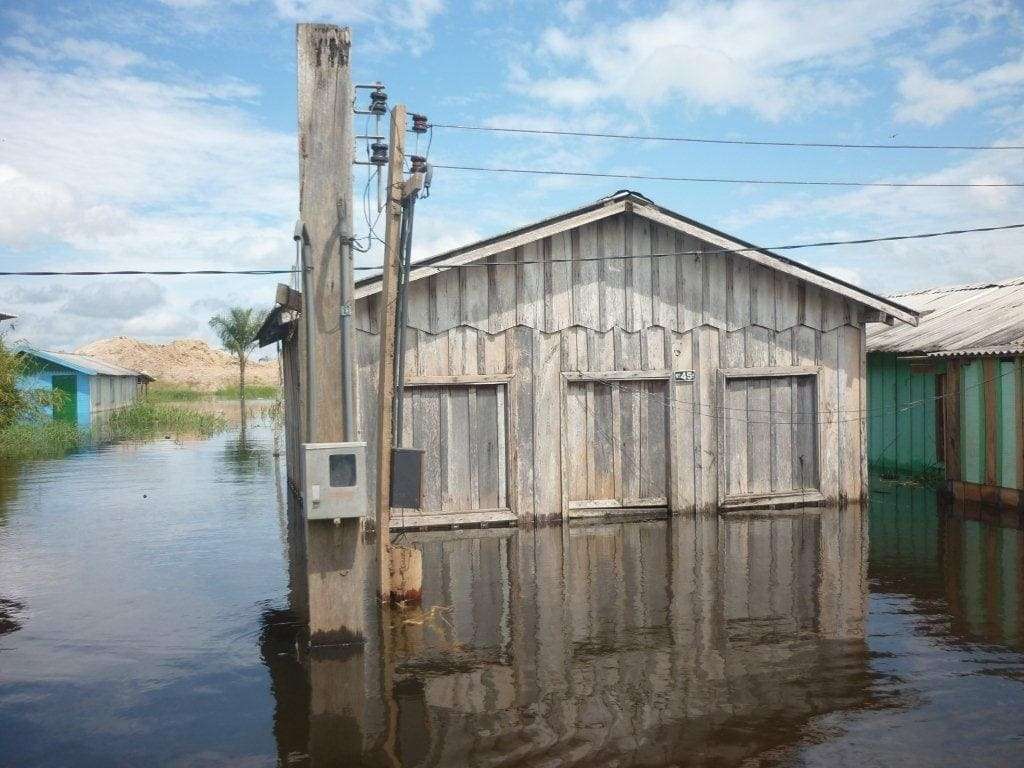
[[0, 401, 227, 459]]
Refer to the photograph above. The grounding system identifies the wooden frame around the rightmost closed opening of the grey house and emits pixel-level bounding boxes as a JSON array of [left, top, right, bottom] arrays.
[[716, 366, 825, 510]]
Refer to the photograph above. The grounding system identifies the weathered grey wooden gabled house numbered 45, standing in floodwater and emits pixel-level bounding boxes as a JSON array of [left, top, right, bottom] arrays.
[[276, 191, 918, 527]]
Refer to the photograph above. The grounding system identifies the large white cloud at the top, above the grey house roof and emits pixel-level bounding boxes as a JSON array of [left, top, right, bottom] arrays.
[[512, 0, 929, 120]]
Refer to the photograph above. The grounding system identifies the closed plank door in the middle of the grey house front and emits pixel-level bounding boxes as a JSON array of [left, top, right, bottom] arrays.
[[562, 379, 669, 510]]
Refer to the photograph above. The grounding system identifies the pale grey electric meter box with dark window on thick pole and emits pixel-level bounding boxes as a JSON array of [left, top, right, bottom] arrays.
[[302, 442, 367, 520]]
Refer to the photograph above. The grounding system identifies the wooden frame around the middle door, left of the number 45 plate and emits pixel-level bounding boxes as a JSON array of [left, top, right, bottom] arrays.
[[559, 369, 676, 519]]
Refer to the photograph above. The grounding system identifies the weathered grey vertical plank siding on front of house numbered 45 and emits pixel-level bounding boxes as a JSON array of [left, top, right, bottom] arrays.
[[355, 213, 865, 519]]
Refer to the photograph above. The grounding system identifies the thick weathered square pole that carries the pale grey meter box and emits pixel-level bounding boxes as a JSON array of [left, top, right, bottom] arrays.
[[296, 24, 377, 645]]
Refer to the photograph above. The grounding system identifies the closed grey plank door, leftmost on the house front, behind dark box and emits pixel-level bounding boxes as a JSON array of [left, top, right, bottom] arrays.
[[392, 384, 509, 519]]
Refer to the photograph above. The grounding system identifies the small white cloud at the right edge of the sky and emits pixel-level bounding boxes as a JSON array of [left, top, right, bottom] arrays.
[[895, 55, 1024, 126]]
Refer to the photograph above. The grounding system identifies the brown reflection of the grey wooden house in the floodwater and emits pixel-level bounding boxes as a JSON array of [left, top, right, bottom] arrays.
[[263, 508, 878, 766]]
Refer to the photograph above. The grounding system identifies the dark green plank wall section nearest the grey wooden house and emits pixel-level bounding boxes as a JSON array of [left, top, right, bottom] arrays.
[[867, 353, 942, 474]]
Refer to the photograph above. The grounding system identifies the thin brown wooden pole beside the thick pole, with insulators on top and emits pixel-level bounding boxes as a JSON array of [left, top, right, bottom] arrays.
[[376, 104, 406, 600]]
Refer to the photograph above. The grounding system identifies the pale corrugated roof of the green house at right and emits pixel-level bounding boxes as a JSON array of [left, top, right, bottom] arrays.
[[867, 276, 1024, 356]]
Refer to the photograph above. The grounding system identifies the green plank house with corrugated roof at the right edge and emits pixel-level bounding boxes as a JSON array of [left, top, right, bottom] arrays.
[[867, 278, 1024, 507]]
